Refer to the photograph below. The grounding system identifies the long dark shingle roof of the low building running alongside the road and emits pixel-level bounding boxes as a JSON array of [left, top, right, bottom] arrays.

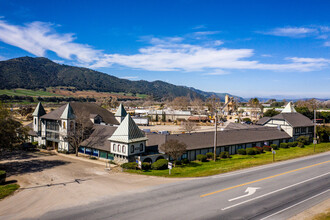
[[147, 126, 291, 150]]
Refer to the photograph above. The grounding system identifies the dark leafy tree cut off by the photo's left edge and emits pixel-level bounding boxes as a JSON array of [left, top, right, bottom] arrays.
[[0, 103, 28, 152]]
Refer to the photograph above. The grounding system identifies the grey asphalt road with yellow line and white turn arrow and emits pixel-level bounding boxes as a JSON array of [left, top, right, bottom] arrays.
[[41, 153, 330, 219]]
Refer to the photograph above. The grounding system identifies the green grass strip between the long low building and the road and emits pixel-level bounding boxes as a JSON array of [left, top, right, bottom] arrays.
[[126, 143, 330, 177]]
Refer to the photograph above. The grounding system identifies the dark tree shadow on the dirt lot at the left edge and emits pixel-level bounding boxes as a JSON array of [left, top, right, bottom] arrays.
[[0, 159, 71, 177]]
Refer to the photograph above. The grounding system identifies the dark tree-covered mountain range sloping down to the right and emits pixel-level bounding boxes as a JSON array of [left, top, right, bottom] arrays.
[[0, 57, 244, 101]]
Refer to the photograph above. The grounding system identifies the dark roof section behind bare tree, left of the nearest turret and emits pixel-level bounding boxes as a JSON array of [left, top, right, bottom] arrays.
[[80, 125, 117, 151]]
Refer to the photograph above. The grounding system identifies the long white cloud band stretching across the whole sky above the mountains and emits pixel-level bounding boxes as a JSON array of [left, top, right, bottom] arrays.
[[0, 20, 329, 75]]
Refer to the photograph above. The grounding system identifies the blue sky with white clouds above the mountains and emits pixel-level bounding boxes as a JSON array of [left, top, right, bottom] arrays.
[[0, 0, 330, 98]]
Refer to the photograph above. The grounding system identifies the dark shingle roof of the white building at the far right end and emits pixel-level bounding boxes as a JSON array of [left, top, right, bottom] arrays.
[[272, 113, 313, 127]]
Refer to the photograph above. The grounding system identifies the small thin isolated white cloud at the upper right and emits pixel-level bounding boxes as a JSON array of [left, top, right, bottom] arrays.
[[264, 27, 318, 37]]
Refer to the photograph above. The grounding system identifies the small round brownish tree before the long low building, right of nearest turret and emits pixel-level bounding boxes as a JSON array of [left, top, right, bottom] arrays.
[[159, 140, 187, 161]]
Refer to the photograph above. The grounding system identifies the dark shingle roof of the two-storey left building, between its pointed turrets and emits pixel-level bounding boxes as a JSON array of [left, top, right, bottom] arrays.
[[41, 102, 119, 125]]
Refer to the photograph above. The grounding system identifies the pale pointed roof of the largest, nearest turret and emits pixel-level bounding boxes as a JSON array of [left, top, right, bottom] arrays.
[[109, 114, 148, 144]]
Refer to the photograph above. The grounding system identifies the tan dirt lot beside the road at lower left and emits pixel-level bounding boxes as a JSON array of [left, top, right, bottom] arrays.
[[0, 152, 182, 219]]
